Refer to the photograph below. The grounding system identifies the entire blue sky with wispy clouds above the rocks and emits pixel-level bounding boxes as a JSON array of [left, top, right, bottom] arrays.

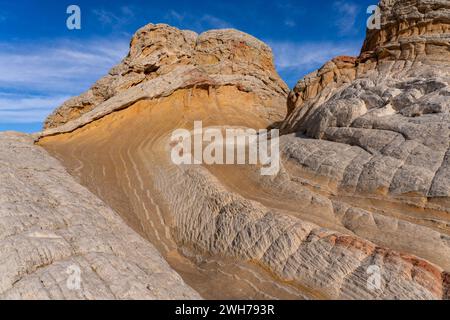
[[0, 0, 377, 132]]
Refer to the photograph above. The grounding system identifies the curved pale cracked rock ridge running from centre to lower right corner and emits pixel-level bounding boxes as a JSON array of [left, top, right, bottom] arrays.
[[159, 168, 448, 299]]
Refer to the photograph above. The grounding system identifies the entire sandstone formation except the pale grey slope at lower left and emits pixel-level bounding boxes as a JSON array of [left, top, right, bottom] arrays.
[[39, 0, 450, 299]]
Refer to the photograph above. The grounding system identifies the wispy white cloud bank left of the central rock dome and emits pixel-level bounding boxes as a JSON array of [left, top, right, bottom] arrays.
[[0, 38, 128, 123]]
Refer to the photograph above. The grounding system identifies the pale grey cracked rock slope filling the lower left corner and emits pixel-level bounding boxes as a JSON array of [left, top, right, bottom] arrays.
[[0, 133, 200, 299]]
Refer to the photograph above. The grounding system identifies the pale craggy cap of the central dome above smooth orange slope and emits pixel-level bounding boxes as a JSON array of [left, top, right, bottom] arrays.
[[45, 24, 289, 132]]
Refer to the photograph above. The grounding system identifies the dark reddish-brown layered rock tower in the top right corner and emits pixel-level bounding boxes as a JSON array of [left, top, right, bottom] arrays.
[[362, 0, 450, 62]]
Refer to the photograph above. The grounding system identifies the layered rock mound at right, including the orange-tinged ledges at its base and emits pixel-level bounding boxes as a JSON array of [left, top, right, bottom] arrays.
[[281, 1, 450, 298]]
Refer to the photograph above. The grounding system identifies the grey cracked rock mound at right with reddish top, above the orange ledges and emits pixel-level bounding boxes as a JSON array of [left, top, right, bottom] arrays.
[[283, 1, 450, 205]]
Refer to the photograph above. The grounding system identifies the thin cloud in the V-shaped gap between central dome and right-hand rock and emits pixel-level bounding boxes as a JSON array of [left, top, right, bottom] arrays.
[[267, 40, 361, 86]]
